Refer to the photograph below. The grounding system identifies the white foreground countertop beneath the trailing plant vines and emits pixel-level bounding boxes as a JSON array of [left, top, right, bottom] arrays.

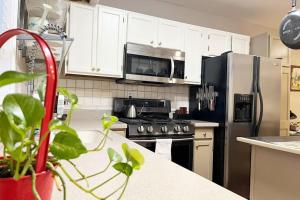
[[52, 130, 245, 200]]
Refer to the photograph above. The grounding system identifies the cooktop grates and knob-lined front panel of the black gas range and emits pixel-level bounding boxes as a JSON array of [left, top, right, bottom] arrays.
[[120, 117, 193, 137]]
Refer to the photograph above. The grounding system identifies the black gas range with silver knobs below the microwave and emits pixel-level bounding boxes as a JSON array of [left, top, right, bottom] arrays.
[[113, 98, 194, 170]]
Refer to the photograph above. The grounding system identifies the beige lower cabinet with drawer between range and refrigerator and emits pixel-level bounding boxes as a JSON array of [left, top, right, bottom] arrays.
[[193, 128, 213, 180]]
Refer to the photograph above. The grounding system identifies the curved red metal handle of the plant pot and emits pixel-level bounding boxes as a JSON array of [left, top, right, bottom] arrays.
[[0, 29, 57, 173]]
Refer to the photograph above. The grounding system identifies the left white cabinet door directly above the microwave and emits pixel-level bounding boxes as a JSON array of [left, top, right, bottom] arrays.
[[127, 12, 158, 45]]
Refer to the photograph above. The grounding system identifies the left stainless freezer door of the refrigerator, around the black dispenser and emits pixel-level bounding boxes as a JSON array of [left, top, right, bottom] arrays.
[[224, 53, 253, 198]]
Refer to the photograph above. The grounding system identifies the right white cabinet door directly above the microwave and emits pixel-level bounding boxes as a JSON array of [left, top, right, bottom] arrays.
[[157, 19, 184, 50]]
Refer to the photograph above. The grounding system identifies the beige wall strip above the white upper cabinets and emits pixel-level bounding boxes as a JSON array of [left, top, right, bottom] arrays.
[[91, 0, 277, 36]]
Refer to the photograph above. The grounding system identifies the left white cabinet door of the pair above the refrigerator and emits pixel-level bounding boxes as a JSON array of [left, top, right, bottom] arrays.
[[208, 30, 231, 56]]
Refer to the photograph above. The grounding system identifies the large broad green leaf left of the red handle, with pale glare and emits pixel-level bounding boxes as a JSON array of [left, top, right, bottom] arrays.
[[3, 94, 45, 128]]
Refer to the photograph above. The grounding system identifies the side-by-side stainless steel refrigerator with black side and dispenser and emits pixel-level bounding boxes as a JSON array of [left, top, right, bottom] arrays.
[[189, 52, 281, 198]]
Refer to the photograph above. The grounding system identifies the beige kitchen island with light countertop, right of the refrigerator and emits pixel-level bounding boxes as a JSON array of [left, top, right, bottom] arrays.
[[237, 136, 300, 200]]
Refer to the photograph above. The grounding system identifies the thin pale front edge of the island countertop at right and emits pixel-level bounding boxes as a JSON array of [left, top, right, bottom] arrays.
[[236, 137, 300, 155]]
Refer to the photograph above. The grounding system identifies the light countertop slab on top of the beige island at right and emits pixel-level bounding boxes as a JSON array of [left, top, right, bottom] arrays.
[[237, 136, 300, 155]]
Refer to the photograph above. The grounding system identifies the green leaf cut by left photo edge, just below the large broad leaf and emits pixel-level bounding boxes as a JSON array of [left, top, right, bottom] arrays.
[[0, 111, 22, 151]]
